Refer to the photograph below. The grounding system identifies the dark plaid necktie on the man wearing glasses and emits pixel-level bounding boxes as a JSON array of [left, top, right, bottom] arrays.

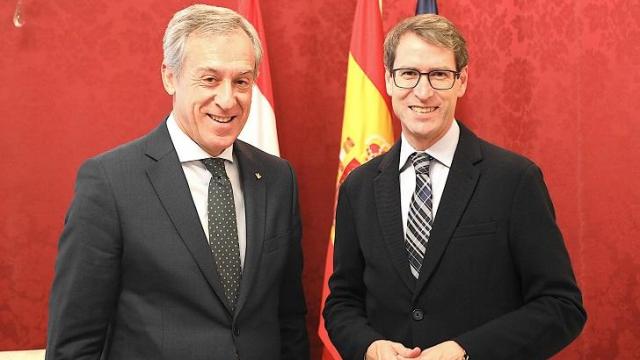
[[404, 153, 433, 279]]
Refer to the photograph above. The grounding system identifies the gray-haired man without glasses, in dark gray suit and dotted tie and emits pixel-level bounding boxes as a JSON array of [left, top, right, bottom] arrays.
[[46, 5, 309, 360]]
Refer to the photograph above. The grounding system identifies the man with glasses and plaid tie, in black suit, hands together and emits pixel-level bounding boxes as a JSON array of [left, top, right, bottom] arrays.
[[323, 15, 586, 360]]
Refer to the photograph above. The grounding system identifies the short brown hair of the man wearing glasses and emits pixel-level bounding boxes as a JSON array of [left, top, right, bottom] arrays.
[[384, 14, 469, 71]]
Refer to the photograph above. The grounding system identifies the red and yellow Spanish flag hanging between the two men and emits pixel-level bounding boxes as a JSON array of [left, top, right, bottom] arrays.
[[318, 0, 393, 360]]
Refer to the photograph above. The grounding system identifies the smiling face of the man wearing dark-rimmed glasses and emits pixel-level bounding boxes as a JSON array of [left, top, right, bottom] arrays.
[[385, 32, 467, 150]]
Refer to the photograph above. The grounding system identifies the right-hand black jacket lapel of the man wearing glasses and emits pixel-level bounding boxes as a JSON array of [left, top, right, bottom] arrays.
[[413, 123, 482, 300]]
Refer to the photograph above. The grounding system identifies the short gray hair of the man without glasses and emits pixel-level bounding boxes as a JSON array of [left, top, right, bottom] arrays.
[[162, 4, 262, 75]]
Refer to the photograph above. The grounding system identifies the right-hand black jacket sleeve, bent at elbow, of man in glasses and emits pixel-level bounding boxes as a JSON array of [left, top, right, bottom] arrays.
[[454, 164, 586, 359]]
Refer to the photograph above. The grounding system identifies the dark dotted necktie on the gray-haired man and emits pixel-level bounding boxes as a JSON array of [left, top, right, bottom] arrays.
[[202, 158, 242, 309]]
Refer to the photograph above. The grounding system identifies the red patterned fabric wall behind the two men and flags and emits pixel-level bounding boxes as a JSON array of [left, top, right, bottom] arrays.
[[0, 0, 640, 359]]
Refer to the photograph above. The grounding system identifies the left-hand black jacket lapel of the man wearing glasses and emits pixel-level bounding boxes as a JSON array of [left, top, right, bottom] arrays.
[[374, 141, 415, 291]]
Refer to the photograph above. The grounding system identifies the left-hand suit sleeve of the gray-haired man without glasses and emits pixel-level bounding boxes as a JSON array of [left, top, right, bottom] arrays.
[[46, 159, 121, 360]]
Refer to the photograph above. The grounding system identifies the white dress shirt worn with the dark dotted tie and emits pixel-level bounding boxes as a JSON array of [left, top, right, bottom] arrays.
[[167, 113, 247, 266]]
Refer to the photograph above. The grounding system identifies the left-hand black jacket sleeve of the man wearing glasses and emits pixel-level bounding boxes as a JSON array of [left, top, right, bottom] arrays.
[[323, 179, 384, 359]]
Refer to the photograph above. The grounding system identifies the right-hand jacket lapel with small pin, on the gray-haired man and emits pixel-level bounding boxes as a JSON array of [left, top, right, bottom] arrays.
[[234, 141, 269, 313]]
